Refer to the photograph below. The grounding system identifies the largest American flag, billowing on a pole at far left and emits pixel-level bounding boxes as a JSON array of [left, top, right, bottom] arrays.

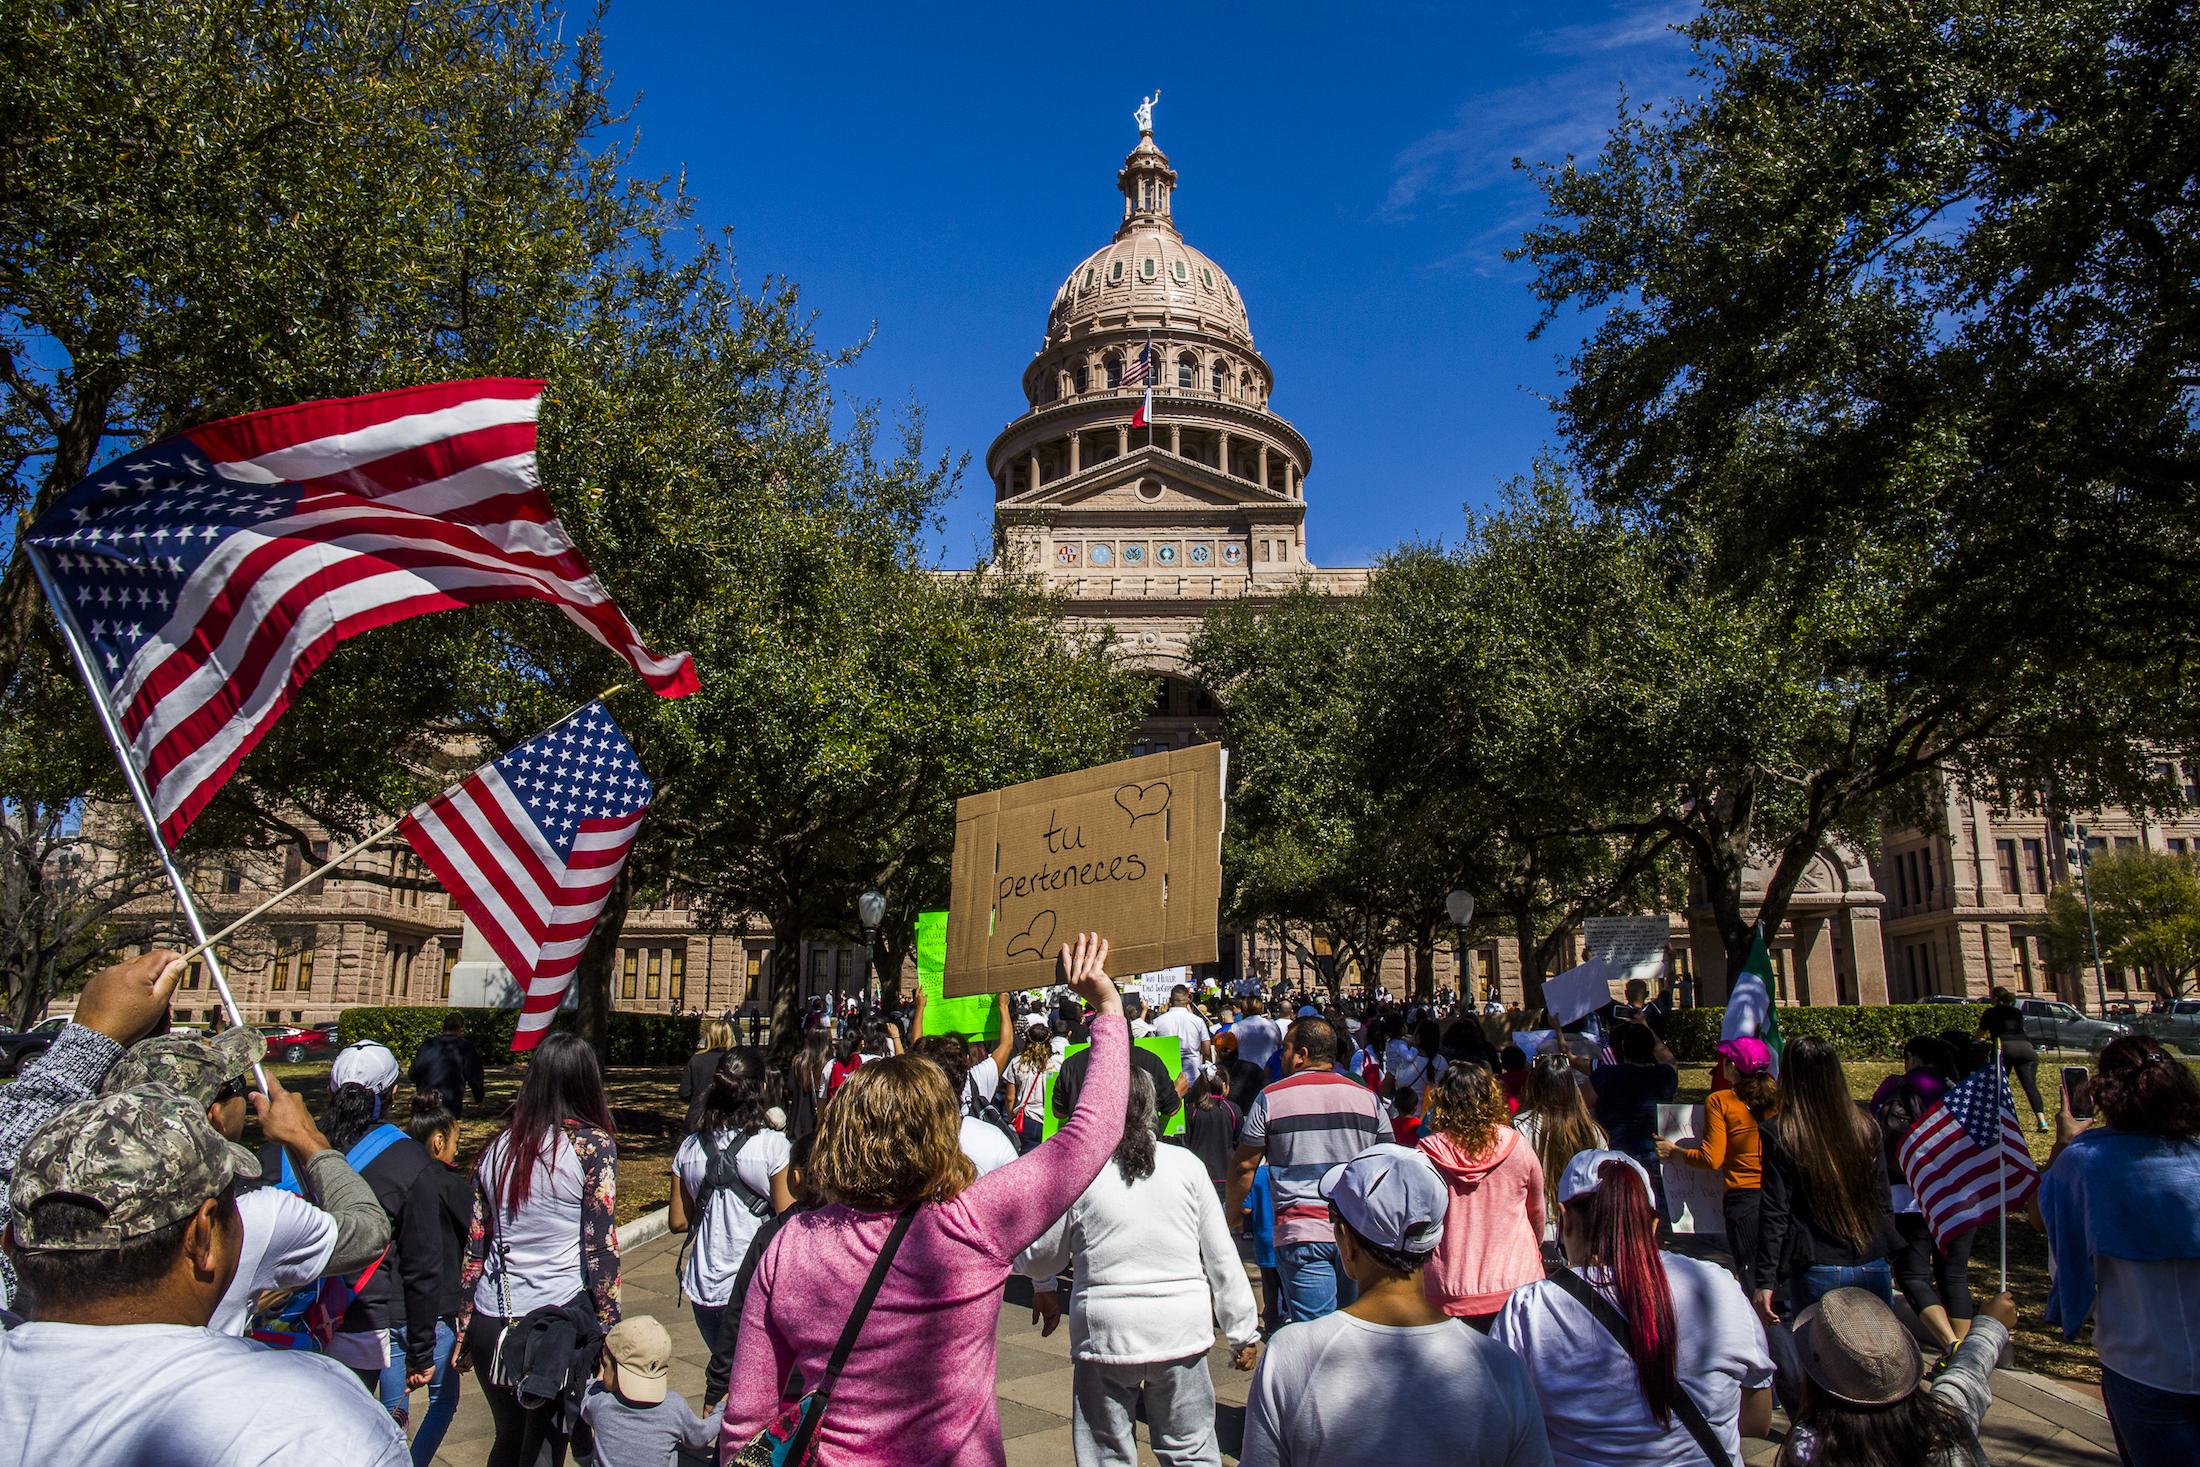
[[24, 378, 695, 845]]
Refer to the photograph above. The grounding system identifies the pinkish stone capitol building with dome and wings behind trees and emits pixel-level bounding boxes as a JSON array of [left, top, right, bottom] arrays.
[[116, 101, 2200, 1023]]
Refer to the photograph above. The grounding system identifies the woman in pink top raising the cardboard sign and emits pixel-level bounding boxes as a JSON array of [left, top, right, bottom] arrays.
[[719, 933, 1131, 1467]]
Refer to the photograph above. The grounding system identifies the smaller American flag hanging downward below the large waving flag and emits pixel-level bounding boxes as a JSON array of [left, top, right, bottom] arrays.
[[398, 699, 656, 1051]]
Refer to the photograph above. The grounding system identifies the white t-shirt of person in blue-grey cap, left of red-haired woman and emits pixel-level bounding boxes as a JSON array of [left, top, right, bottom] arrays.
[[1239, 1311, 1557, 1467]]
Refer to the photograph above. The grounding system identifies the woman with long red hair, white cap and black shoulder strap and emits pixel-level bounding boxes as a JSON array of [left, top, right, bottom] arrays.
[[1489, 1150, 1773, 1467]]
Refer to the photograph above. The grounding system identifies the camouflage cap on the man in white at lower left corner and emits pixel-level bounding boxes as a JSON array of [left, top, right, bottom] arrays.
[[7, 1087, 260, 1251]]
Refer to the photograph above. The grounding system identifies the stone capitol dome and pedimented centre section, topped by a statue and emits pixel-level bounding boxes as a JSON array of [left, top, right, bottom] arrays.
[[986, 95, 1366, 752]]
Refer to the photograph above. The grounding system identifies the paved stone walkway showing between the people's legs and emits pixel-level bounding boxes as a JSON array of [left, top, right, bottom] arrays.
[[414, 1238, 2116, 1467]]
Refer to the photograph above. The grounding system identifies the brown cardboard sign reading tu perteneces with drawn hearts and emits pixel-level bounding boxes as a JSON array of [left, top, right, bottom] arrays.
[[944, 743, 1225, 996]]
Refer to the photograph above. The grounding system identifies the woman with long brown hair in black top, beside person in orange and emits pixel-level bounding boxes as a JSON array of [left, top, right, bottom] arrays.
[[1751, 1038, 1894, 1324]]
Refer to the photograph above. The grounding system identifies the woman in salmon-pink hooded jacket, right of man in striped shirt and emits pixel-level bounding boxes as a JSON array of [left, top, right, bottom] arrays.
[[1421, 1062, 1544, 1333]]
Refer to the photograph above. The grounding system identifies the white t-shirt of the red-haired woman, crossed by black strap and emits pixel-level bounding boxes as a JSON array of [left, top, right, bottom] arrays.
[[1489, 1254, 1773, 1467]]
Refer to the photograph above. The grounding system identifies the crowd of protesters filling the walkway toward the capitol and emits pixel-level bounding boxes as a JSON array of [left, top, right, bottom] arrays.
[[0, 935, 2200, 1467]]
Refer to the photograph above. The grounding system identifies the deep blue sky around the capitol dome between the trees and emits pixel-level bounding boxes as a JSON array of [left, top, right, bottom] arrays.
[[607, 0, 1694, 565]]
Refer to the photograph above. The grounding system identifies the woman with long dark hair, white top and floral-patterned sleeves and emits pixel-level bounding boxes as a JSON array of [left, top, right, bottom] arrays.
[[458, 1034, 618, 1467]]
